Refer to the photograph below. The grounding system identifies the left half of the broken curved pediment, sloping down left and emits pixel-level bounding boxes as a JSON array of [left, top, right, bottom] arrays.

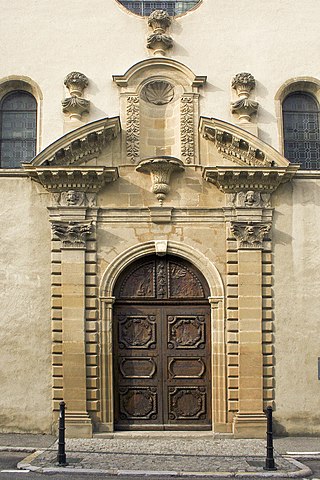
[[22, 117, 120, 168]]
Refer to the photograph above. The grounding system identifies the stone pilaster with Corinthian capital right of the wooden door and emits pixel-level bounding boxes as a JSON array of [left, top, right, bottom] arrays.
[[231, 222, 271, 438]]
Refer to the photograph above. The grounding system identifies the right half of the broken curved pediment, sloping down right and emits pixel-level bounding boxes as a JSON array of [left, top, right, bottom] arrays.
[[199, 117, 292, 170]]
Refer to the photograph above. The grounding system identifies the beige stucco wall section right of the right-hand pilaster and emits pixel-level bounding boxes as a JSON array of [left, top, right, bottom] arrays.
[[273, 179, 320, 434]]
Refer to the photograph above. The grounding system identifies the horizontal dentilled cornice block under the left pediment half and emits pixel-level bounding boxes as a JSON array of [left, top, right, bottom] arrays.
[[25, 165, 119, 193]]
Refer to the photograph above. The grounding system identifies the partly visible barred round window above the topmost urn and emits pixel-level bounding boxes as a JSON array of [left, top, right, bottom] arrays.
[[120, 0, 199, 17]]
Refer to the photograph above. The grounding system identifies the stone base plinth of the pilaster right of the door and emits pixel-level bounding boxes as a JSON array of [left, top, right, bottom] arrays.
[[233, 413, 267, 438]]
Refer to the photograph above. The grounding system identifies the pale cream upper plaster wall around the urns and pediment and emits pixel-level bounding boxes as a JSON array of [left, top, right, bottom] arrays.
[[0, 0, 320, 148]]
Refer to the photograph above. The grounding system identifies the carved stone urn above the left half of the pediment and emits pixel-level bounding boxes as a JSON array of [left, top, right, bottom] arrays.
[[62, 72, 90, 120]]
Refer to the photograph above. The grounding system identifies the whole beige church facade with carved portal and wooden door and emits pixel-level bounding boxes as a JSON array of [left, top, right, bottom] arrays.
[[0, 0, 320, 438]]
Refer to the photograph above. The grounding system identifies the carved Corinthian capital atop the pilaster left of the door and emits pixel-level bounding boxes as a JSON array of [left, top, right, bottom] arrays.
[[52, 221, 93, 248]]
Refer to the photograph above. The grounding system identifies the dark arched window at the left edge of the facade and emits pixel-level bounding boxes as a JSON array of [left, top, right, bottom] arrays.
[[0, 90, 37, 168]]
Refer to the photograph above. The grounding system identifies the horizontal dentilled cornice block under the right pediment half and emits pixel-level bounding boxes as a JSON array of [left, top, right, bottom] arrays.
[[203, 164, 299, 193]]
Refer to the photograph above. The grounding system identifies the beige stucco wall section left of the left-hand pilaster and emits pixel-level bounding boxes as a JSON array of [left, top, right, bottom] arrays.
[[0, 176, 52, 433]]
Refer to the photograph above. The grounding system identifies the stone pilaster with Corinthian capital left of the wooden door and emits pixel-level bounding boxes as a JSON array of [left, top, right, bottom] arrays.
[[52, 221, 92, 438]]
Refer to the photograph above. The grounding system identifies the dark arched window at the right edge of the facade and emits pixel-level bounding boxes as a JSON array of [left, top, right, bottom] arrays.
[[282, 92, 320, 170]]
